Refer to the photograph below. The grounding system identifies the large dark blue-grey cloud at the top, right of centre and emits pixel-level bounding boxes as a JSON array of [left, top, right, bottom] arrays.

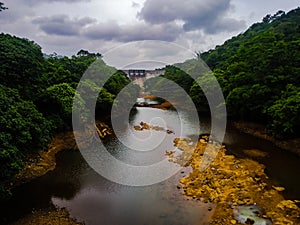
[[138, 0, 245, 34]]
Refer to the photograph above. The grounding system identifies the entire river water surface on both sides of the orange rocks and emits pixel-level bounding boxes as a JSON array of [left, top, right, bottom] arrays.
[[0, 108, 300, 225]]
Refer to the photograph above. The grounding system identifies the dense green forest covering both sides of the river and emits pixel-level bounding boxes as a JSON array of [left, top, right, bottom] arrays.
[[0, 8, 300, 197]]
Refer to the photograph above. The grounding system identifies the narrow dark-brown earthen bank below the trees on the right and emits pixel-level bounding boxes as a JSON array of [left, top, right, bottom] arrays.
[[232, 121, 300, 157]]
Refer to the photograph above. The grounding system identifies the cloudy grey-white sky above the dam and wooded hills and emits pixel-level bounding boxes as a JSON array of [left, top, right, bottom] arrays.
[[0, 0, 300, 67]]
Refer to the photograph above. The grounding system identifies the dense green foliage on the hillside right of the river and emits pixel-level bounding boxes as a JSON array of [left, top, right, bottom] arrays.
[[146, 8, 300, 137]]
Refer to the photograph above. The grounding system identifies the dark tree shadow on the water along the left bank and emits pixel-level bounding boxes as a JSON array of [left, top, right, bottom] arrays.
[[0, 151, 84, 224]]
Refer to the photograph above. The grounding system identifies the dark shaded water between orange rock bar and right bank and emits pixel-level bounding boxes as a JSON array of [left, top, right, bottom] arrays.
[[224, 125, 300, 199]]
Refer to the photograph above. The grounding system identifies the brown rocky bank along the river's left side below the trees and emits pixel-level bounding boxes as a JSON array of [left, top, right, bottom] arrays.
[[3, 121, 112, 225]]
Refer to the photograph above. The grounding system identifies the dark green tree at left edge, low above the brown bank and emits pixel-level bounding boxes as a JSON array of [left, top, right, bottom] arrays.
[[0, 85, 50, 197]]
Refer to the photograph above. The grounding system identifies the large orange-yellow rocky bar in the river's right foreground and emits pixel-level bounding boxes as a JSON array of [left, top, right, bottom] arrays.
[[170, 136, 300, 225]]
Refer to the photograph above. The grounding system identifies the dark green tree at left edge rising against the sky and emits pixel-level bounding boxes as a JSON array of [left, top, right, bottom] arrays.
[[0, 33, 44, 99]]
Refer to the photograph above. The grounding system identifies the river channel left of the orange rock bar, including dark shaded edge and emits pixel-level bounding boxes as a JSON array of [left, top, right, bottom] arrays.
[[0, 108, 212, 225]]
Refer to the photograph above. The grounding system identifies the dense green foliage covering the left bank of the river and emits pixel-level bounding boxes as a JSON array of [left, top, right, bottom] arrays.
[[0, 34, 138, 197]]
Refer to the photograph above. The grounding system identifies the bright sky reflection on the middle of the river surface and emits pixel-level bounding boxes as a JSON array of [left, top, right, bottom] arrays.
[[51, 108, 211, 225]]
